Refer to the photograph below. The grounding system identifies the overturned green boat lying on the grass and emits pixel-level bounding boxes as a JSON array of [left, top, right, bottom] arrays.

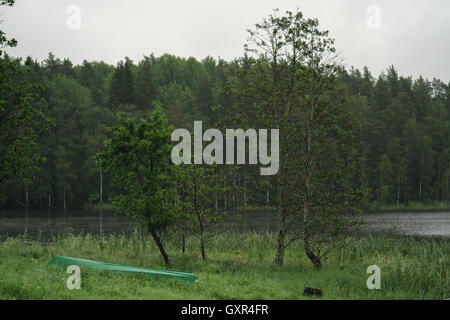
[[48, 256, 197, 283]]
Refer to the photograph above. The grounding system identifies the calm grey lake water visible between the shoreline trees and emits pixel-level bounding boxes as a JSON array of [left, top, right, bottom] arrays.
[[0, 210, 450, 237]]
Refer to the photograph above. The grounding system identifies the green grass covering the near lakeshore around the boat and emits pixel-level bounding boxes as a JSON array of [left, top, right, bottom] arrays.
[[0, 233, 450, 299]]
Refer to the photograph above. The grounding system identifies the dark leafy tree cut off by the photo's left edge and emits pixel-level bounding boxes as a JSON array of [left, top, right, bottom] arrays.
[[0, 0, 49, 184]]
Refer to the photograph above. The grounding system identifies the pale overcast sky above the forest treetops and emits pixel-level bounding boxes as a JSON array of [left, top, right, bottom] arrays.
[[0, 0, 450, 82]]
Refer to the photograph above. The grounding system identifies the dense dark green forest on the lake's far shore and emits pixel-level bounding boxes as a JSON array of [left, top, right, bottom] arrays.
[[0, 53, 450, 210]]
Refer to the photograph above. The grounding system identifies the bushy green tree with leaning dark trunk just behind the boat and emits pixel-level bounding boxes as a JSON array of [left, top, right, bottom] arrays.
[[96, 108, 177, 267]]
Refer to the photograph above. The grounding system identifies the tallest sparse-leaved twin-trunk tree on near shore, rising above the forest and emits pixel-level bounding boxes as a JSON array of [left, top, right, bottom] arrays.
[[230, 11, 364, 268]]
